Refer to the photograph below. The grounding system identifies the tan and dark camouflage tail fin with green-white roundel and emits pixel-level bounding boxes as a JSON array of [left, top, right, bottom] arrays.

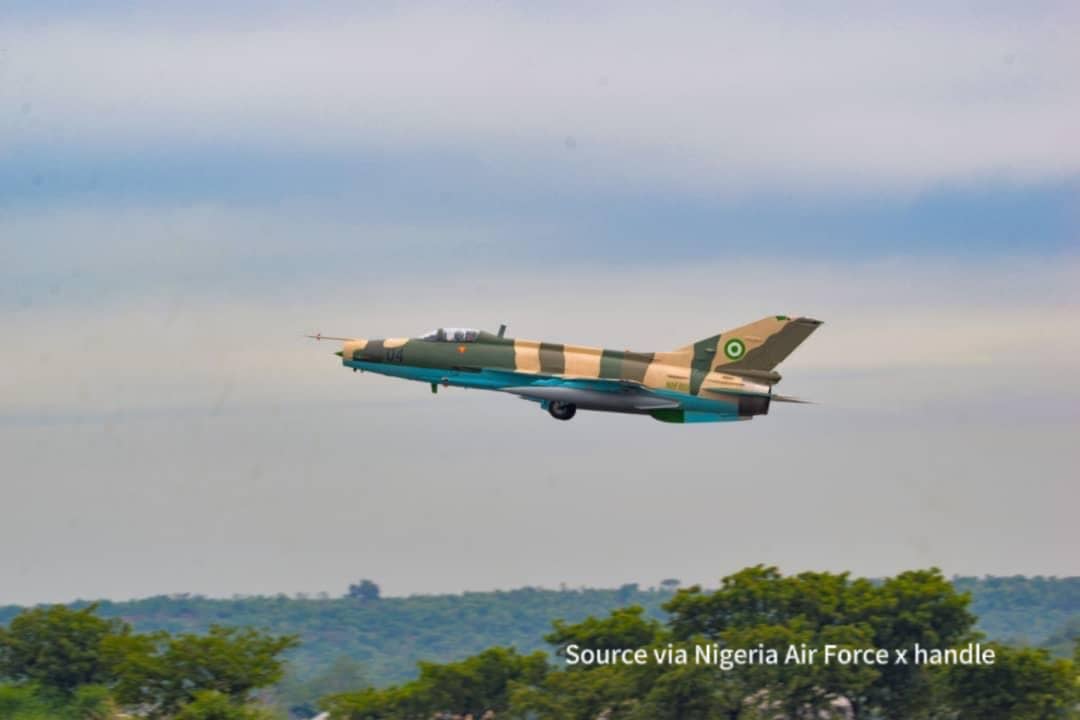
[[679, 315, 822, 378]]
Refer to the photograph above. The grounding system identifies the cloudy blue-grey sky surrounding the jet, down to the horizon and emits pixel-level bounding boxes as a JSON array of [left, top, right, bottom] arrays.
[[0, 0, 1080, 603]]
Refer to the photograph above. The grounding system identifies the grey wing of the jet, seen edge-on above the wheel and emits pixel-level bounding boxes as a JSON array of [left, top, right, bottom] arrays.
[[501, 378, 679, 412]]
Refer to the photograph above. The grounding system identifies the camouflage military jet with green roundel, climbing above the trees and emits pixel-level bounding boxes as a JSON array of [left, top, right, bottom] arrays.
[[308, 315, 822, 422]]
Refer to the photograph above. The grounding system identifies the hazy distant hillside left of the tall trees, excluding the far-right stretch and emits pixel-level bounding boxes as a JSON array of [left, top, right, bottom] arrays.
[[0, 585, 672, 684]]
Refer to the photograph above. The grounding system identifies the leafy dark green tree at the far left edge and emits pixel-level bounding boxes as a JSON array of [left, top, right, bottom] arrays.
[[0, 604, 131, 695]]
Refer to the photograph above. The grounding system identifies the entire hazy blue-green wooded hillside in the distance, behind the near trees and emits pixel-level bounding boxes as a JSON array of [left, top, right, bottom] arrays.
[[0, 578, 1080, 684]]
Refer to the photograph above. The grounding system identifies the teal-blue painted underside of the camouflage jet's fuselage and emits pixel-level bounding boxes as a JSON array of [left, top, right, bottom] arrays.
[[342, 359, 746, 423]]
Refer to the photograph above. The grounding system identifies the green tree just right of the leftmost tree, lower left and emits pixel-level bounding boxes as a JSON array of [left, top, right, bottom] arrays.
[[117, 625, 298, 717]]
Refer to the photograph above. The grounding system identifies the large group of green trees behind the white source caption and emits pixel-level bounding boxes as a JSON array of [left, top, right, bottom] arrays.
[[324, 567, 1080, 720]]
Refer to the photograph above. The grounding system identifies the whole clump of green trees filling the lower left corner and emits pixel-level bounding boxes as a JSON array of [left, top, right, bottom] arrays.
[[0, 606, 297, 720]]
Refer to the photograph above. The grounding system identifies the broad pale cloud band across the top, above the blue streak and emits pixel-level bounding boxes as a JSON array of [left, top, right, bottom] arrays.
[[6, 3, 1080, 192]]
